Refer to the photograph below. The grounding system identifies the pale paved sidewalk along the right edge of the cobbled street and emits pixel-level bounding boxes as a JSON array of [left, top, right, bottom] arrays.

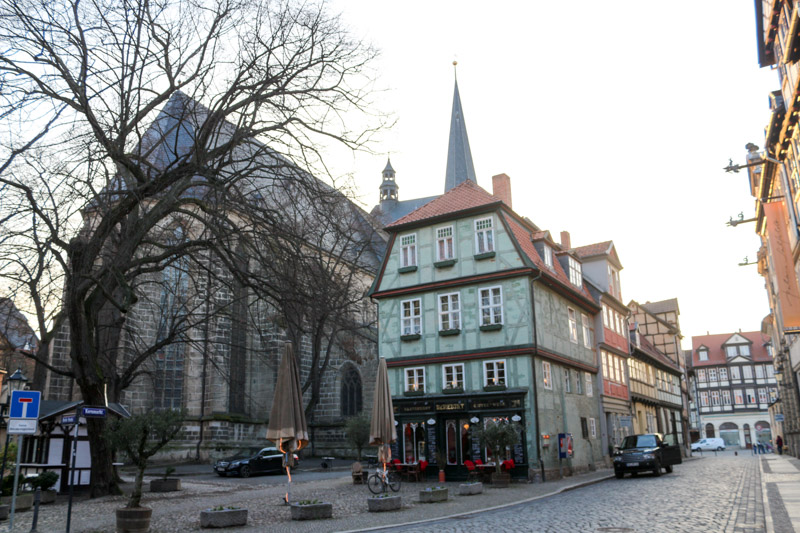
[[760, 453, 800, 533]]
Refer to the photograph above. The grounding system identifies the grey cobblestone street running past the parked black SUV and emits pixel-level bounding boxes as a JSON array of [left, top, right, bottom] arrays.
[[383, 454, 764, 533]]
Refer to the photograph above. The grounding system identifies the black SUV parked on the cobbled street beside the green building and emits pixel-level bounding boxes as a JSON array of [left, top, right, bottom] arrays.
[[614, 433, 683, 479]]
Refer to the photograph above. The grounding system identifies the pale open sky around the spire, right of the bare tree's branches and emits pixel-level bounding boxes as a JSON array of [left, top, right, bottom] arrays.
[[332, 0, 779, 348]]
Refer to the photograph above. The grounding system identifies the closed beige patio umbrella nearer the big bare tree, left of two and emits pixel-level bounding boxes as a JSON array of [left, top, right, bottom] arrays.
[[267, 342, 308, 503]]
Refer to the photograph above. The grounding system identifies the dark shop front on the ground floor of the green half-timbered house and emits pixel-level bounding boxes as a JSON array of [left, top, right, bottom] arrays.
[[392, 389, 528, 479]]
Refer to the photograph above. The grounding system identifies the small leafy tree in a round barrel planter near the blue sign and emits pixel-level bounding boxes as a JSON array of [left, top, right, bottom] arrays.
[[105, 410, 183, 533]]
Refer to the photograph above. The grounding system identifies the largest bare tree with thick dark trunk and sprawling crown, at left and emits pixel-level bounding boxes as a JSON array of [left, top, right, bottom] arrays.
[[0, 0, 374, 496]]
